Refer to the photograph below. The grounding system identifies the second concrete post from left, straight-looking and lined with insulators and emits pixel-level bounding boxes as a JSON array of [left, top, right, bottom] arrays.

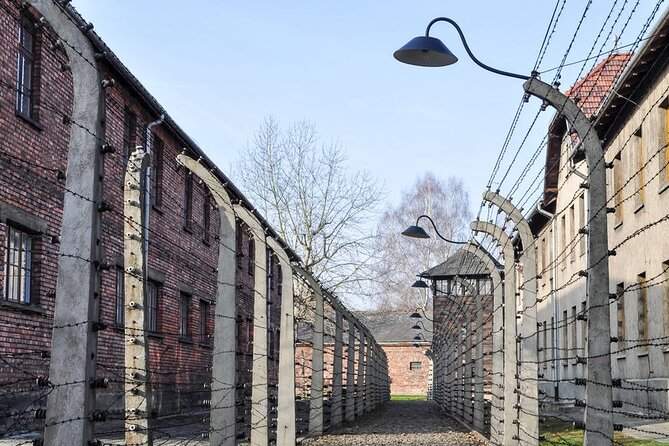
[[123, 150, 153, 445]]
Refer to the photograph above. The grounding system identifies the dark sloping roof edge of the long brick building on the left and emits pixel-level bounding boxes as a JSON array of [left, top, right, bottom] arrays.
[[58, 3, 300, 261]]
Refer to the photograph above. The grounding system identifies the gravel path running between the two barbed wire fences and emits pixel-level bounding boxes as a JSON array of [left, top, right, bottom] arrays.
[[302, 401, 485, 446]]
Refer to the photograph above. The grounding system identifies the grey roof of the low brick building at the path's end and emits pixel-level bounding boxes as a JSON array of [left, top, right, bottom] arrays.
[[356, 310, 432, 344]]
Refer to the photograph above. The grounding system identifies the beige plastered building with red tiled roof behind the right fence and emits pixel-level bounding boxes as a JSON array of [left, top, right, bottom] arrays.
[[530, 8, 669, 411]]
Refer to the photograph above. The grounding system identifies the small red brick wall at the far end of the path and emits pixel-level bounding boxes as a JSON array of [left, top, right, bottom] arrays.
[[381, 343, 430, 395]]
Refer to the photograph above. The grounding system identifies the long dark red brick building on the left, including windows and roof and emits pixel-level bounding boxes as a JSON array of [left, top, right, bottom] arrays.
[[0, 0, 297, 440]]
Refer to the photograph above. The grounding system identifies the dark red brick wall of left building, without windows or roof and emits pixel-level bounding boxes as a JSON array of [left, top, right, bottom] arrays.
[[0, 0, 281, 432]]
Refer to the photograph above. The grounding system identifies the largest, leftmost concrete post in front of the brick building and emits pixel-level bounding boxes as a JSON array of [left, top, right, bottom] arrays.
[[28, 0, 105, 445]]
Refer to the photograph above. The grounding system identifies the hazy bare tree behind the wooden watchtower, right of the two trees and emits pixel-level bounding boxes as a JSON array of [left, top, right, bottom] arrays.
[[376, 172, 471, 310]]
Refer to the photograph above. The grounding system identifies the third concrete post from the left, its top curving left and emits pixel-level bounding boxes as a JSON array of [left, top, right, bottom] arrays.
[[177, 154, 237, 445]]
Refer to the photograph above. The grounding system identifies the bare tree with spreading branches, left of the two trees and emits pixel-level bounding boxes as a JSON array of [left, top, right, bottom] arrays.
[[234, 118, 383, 304]]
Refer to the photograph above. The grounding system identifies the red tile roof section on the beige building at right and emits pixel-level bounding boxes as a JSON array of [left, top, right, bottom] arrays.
[[565, 53, 632, 118]]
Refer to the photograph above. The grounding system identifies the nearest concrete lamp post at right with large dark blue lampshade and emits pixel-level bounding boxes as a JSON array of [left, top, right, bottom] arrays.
[[394, 17, 613, 446]]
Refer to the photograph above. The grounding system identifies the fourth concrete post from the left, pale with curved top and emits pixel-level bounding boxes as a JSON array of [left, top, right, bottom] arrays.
[[233, 204, 269, 446]]
